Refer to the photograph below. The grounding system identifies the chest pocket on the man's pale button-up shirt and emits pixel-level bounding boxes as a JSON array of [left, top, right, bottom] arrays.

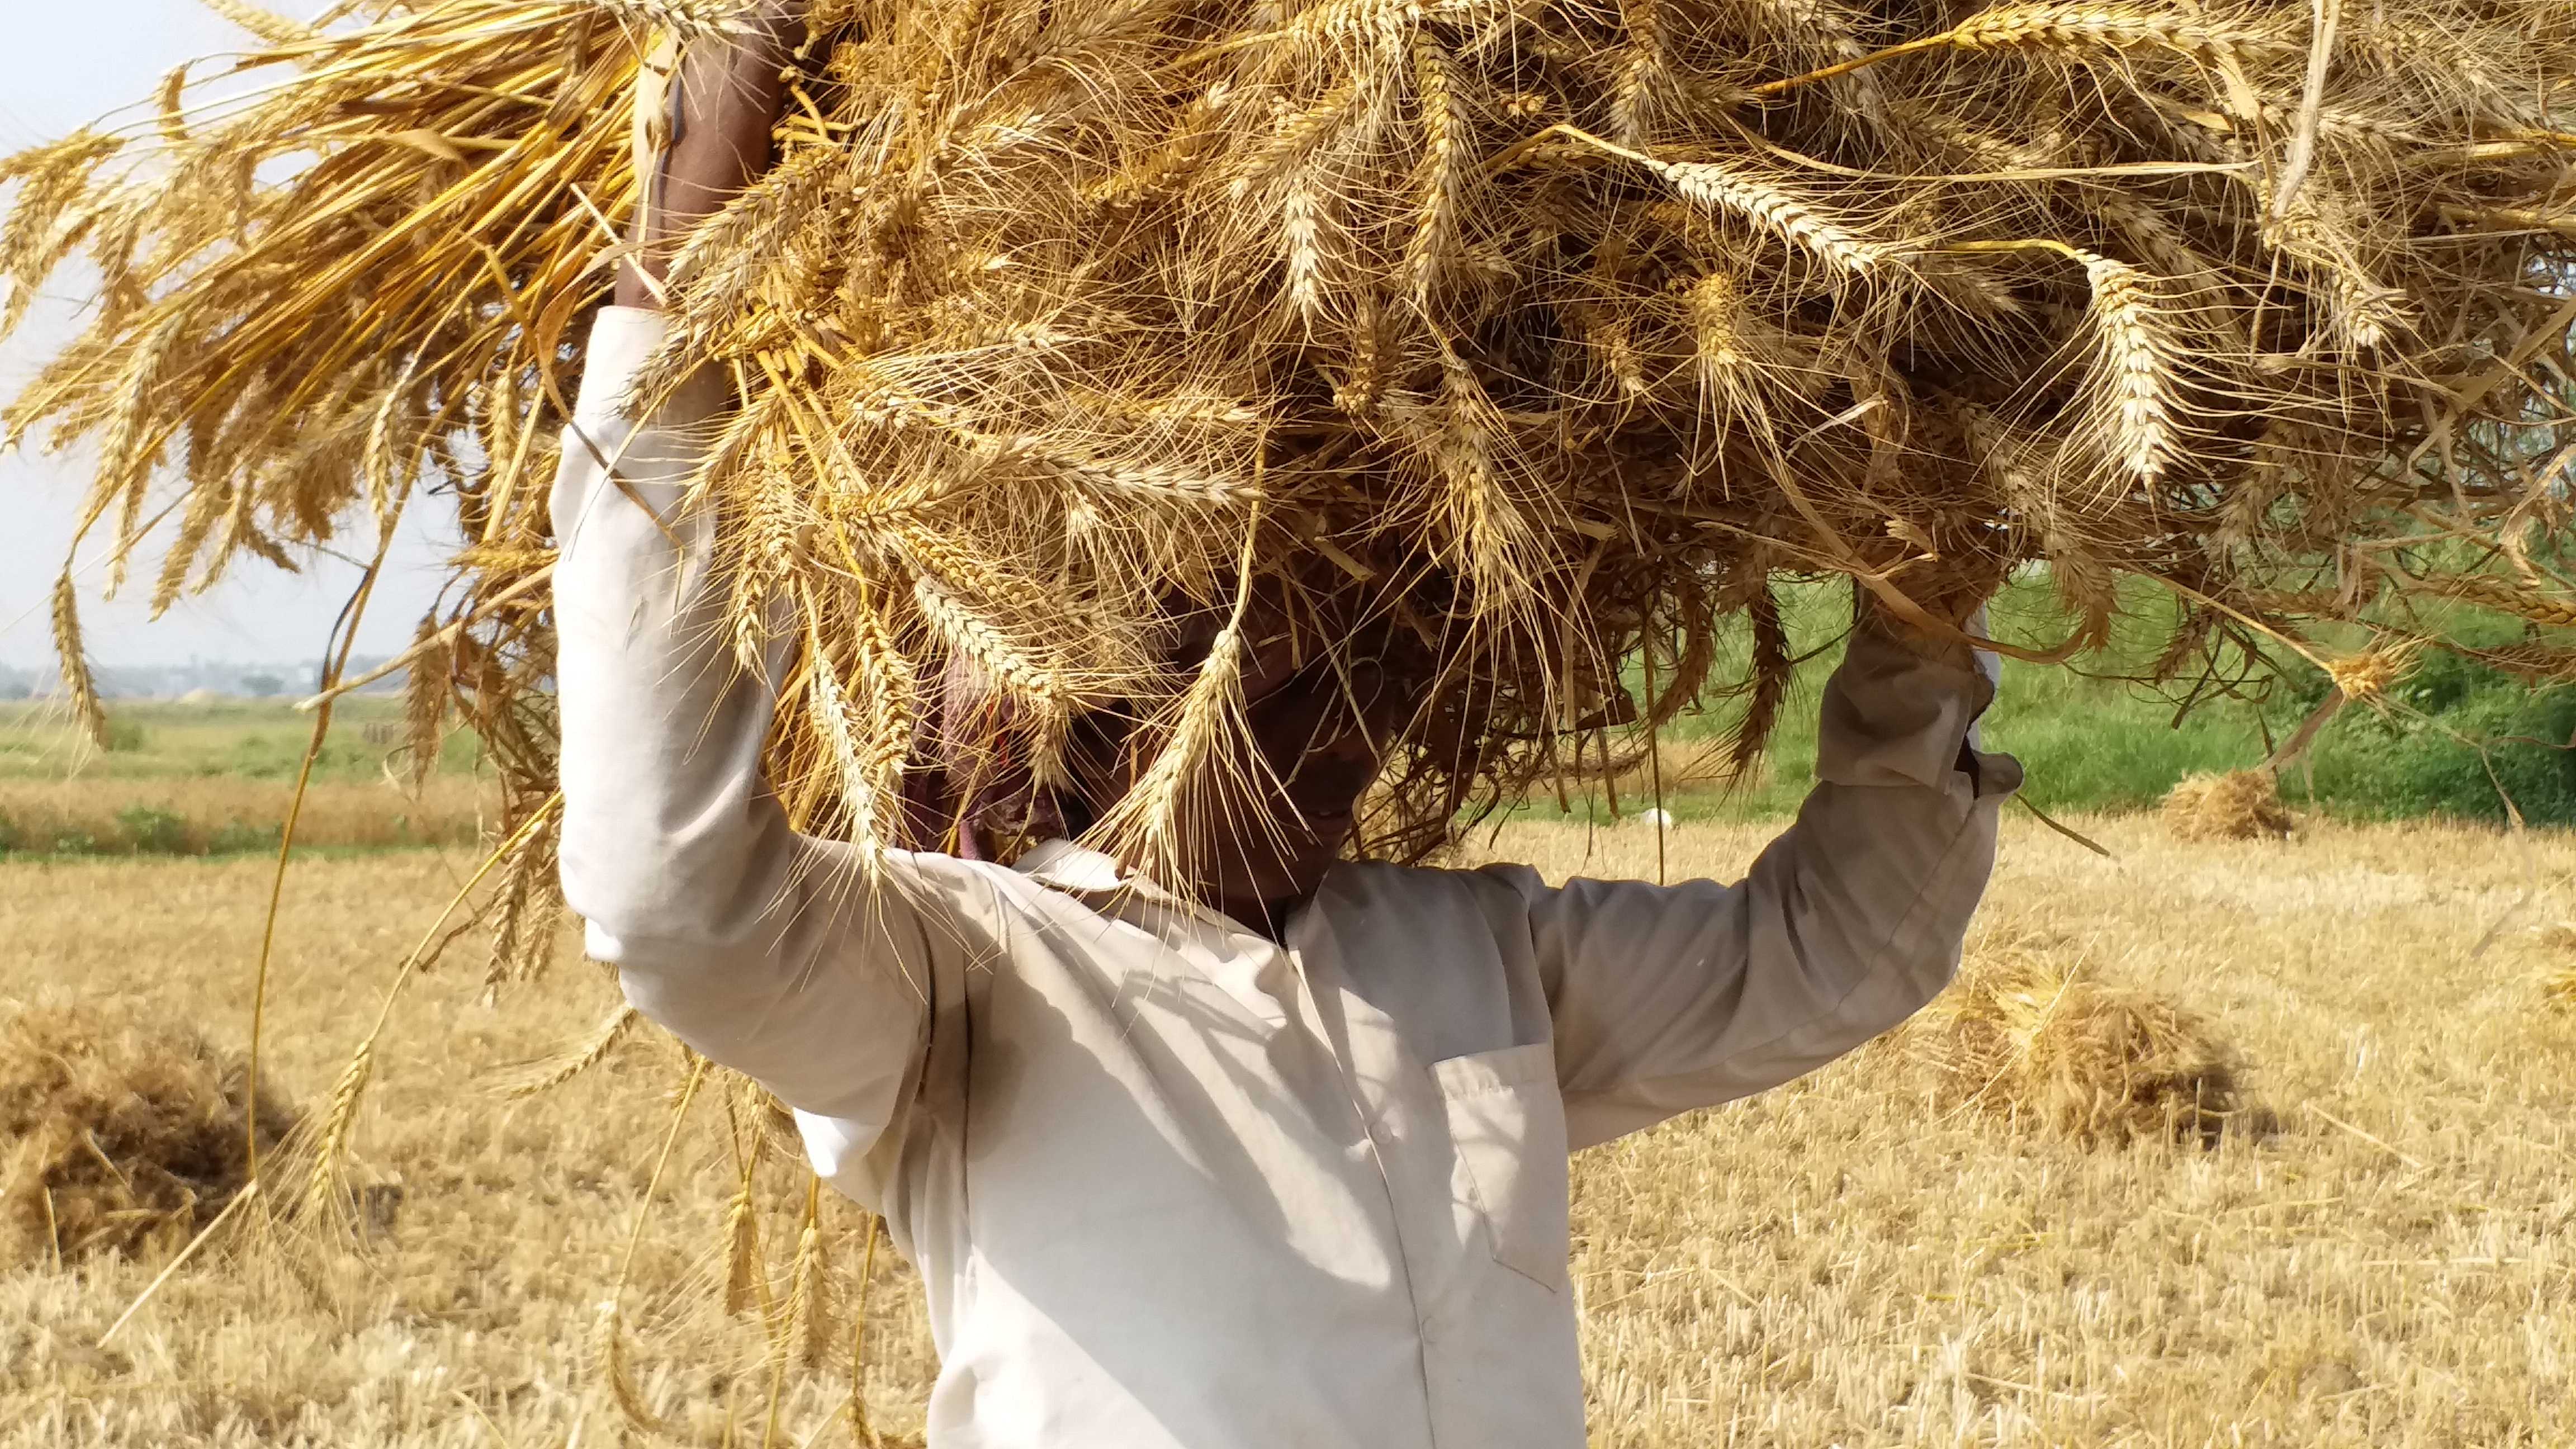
[[1432, 1041, 1566, 1292]]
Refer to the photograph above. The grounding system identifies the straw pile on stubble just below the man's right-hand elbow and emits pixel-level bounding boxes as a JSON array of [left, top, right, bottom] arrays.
[[1896, 934, 2246, 1147]]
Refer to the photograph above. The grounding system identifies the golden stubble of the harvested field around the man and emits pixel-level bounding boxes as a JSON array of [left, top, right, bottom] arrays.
[[0, 817, 2576, 1449]]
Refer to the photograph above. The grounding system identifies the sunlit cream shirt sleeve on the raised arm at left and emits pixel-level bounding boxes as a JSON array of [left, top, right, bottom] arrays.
[[551, 307, 971, 1201]]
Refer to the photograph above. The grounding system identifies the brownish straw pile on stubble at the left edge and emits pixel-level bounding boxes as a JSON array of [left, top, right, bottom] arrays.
[[0, 1008, 291, 1268]]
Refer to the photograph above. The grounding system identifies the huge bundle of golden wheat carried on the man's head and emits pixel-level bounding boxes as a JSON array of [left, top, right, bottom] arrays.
[[0, 0, 2576, 923]]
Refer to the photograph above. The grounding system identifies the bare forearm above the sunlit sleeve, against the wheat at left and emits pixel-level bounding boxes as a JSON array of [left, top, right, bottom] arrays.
[[618, 0, 812, 309]]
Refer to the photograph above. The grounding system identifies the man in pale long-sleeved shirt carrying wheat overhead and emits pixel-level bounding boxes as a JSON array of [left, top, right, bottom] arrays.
[[554, 17, 2020, 1449]]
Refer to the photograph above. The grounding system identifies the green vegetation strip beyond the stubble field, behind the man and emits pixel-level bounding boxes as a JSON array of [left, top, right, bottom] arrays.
[[0, 580, 2576, 856]]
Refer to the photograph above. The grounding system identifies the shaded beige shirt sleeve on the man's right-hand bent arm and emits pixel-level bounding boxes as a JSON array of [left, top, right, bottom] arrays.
[[1515, 613, 2022, 1147]]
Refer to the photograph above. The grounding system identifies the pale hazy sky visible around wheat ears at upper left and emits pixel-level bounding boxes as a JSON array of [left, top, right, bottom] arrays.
[[0, 0, 441, 668]]
